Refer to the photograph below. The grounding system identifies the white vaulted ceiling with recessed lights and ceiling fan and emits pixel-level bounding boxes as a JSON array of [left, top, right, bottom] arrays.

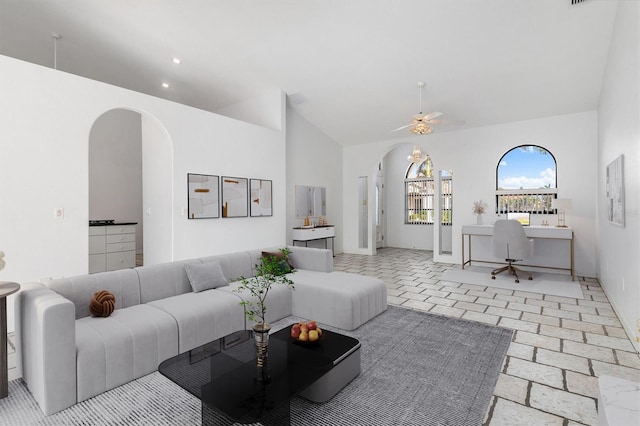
[[0, 0, 618, 145]]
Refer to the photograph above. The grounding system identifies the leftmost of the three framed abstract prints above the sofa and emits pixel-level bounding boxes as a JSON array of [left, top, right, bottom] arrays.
[[187, 173, 220, 219]]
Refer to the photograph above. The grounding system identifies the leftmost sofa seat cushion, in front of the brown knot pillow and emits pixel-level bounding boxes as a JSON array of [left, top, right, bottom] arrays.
[[76, 305, 178, 402]]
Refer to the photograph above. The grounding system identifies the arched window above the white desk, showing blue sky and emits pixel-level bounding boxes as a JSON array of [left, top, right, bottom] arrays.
[[496, 145, 557, 214]]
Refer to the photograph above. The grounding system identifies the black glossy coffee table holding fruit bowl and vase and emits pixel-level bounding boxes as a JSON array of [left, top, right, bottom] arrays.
[[158, 327, 360, 425]]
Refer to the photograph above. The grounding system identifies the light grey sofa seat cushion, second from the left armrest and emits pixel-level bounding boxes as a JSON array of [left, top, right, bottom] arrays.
[[149, 287, 245, 353]]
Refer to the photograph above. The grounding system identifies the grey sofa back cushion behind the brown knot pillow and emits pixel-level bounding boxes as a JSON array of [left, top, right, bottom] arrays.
[[45, 269, 140, 319]]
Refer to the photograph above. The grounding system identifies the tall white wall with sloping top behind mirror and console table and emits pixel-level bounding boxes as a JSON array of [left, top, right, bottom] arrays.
[[287, 107, 342, 253]]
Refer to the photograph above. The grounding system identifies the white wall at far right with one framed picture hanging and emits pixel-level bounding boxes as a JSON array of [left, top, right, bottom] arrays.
[[597, 2, 640, 350]]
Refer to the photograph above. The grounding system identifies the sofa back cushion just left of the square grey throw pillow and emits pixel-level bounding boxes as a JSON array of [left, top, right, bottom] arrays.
[[135, 259, 200, 303]]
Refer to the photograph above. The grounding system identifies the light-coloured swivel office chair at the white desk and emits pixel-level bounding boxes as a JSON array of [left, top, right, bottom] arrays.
[[491, 220, 533, 283]]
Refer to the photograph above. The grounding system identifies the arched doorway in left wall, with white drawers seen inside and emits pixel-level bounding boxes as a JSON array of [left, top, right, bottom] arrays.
[[89, 108, 173, 269]]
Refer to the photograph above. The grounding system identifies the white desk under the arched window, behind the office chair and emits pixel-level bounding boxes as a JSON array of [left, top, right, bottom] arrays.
[[462, 225, 573, 279]]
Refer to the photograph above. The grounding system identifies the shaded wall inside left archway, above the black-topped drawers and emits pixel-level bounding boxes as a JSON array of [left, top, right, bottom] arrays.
[[89, 109, 143, 253]]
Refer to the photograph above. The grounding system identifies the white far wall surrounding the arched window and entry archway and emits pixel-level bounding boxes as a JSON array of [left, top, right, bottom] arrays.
[[343, 111, 597, 277]]
